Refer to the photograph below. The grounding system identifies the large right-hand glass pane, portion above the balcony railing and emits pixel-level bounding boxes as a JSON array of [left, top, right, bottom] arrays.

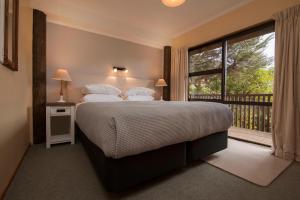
[[226, 32, 275, 95]]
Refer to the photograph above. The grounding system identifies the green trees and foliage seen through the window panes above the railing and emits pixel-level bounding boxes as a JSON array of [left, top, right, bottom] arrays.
[[189, 34, 274, 94]]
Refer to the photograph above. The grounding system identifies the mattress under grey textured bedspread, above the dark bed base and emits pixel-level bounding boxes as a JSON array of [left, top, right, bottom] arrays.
[[76, 101, 232, 159]]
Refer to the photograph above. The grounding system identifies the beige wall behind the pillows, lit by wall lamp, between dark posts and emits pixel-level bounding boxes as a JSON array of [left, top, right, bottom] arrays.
[[47, 23, 163, 102]]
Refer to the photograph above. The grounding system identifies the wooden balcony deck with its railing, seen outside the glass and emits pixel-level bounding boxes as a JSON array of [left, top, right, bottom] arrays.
[[189, 94, 273, 146]]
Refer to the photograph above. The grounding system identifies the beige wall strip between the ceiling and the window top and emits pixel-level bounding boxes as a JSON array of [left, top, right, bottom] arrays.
[[172, 0, 300, 47]]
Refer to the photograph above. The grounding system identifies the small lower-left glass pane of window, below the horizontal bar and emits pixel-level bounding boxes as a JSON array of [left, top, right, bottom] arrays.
[[189, 74, 221, 99]]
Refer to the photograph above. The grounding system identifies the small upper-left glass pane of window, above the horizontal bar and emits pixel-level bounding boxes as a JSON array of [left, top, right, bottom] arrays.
[[189, 43, 222, 73]]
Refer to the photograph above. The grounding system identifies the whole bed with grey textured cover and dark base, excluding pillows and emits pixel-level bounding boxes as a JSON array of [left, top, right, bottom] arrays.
[[76, 101, 232, 192]]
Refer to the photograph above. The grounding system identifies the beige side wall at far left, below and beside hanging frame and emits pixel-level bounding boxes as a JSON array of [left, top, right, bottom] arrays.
[[0, 3, 32, 198]]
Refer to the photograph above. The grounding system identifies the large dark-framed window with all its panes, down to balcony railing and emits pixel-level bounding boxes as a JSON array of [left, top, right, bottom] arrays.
[[188, 22, 275, 102]]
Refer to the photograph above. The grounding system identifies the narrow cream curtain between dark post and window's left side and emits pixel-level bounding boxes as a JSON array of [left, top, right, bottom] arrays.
[[171, 48, 188, 101]]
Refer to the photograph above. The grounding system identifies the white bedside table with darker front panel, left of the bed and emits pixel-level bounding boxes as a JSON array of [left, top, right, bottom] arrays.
[[46, 102, 75, 148]]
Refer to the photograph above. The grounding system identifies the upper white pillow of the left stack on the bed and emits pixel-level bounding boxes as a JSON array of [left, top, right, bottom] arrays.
[[81, 84, 121, 95]]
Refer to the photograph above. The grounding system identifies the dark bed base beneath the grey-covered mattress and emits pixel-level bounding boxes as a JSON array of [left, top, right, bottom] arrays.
[[76, 125, 227, 192]]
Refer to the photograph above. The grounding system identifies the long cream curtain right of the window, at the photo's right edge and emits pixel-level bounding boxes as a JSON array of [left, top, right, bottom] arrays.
[[272, 5, 300, 161]]
